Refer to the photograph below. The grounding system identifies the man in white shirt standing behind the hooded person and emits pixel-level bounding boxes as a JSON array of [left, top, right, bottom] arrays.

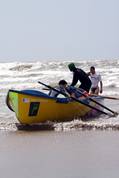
[[88, 66, 103, 95]]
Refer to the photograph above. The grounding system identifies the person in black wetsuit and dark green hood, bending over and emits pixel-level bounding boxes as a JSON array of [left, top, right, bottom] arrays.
[[68, 63, 91, 92]]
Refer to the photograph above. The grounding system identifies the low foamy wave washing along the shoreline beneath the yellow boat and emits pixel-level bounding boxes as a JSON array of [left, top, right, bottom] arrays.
[[0, 116, 119, 132]]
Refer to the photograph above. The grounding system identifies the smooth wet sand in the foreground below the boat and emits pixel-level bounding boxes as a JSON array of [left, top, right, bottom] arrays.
[[0, 130, 119, 178]]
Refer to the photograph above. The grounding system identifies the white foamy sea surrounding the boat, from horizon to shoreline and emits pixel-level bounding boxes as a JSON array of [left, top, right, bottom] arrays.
[[0, 60, 119, 131]]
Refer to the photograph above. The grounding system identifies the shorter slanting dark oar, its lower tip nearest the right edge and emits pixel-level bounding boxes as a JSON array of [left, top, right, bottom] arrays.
[[78, 90, 118, 116]]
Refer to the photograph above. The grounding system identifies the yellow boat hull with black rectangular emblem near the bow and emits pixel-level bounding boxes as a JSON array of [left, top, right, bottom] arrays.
[[7, 90, 101, 124]]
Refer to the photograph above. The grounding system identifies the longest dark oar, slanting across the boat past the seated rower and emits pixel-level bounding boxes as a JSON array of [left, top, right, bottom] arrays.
[[38, 81, 115, 116]]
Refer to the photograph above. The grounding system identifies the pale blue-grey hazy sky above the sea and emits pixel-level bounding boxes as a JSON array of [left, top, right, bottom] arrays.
[[0, 0, 119, 61]]
